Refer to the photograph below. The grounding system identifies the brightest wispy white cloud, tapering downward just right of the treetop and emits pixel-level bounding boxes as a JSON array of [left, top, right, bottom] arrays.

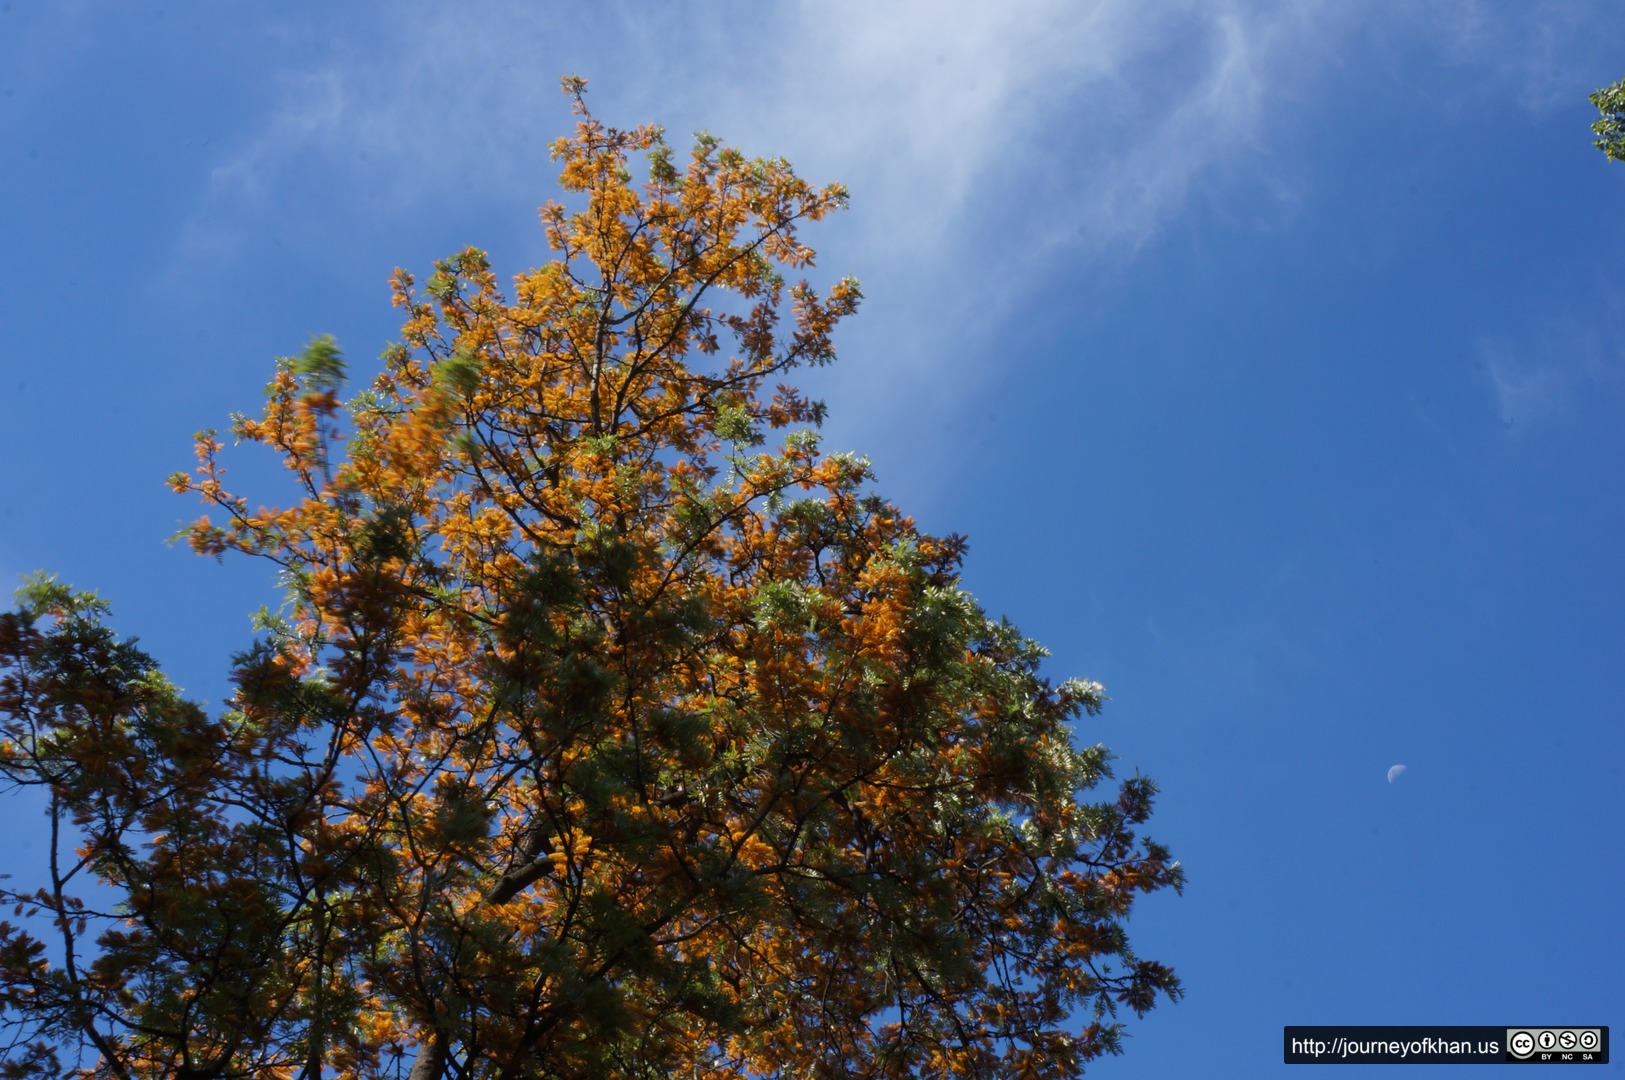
[[640, 0, 1347, 467]]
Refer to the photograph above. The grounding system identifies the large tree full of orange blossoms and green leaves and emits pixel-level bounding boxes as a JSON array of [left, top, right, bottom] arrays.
[[0, 80, 1181, 1080]]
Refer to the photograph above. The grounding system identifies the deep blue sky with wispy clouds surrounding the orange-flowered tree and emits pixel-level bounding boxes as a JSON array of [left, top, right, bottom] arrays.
[[0, 0, 1625, 1077]]
